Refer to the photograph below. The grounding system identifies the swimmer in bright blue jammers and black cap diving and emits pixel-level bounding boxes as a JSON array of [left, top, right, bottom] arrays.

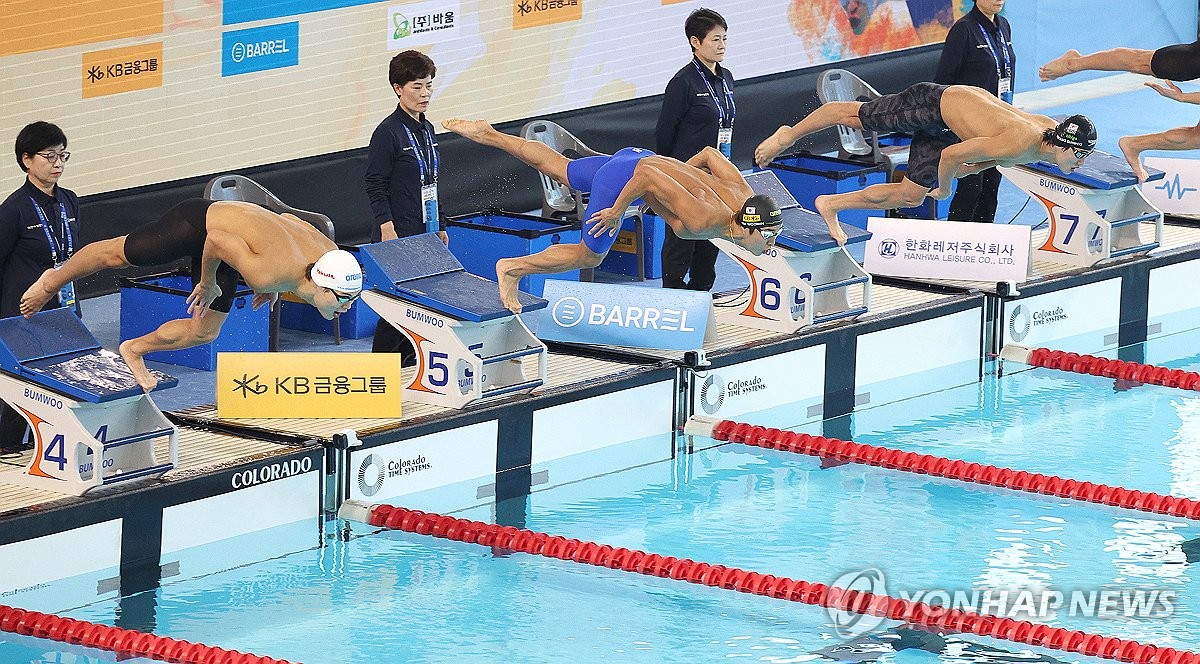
[[442, 119, 782, 313]]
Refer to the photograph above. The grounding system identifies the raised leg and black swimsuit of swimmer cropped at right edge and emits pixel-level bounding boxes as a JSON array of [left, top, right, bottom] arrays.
[[1038, 41, 1200, 80]]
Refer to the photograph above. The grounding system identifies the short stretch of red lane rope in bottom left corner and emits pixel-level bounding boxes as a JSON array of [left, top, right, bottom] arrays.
[[0, 605, 290, 664]]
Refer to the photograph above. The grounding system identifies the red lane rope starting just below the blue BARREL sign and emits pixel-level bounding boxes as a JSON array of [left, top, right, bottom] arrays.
[[712, 420, 1200, 519]]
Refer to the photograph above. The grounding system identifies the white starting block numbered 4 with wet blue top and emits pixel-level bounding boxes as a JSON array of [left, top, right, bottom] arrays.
[[0, 309, 179, 496]]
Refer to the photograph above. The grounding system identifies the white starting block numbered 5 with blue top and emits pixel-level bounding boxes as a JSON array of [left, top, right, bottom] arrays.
[[360, 233, 547, 408]]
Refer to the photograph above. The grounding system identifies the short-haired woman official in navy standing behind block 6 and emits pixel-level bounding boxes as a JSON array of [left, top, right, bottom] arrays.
[[654, 7, 737, 291]]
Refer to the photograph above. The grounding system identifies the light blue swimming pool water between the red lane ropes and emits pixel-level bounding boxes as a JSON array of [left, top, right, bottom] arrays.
[[0, 334, 1200, 664]]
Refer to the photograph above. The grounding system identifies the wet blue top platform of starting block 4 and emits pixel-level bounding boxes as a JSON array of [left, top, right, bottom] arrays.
[[0, 309, 179, 403]]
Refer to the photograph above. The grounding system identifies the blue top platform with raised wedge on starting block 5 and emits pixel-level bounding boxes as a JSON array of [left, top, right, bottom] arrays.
[[360, 233, 547, 323]]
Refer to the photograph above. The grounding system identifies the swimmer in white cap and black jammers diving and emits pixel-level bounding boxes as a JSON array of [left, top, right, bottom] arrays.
[[20, 198, 362, 391]]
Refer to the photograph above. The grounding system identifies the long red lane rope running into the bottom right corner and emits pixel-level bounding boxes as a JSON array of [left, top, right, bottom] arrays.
[[367, 504, 1200, 664]]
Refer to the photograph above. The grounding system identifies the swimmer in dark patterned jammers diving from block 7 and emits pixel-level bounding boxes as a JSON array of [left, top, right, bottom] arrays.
[[754, 83, 1096, 237]]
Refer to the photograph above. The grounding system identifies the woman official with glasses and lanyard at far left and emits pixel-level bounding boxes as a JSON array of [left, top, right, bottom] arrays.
[[0, 121, 79, 453]]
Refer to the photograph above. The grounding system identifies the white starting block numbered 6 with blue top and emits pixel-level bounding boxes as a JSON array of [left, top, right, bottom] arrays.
[[710, 171, 871, 333]]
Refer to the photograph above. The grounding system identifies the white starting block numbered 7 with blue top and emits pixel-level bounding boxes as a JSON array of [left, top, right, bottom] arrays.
[[1000, 150, 1163, 267]]
